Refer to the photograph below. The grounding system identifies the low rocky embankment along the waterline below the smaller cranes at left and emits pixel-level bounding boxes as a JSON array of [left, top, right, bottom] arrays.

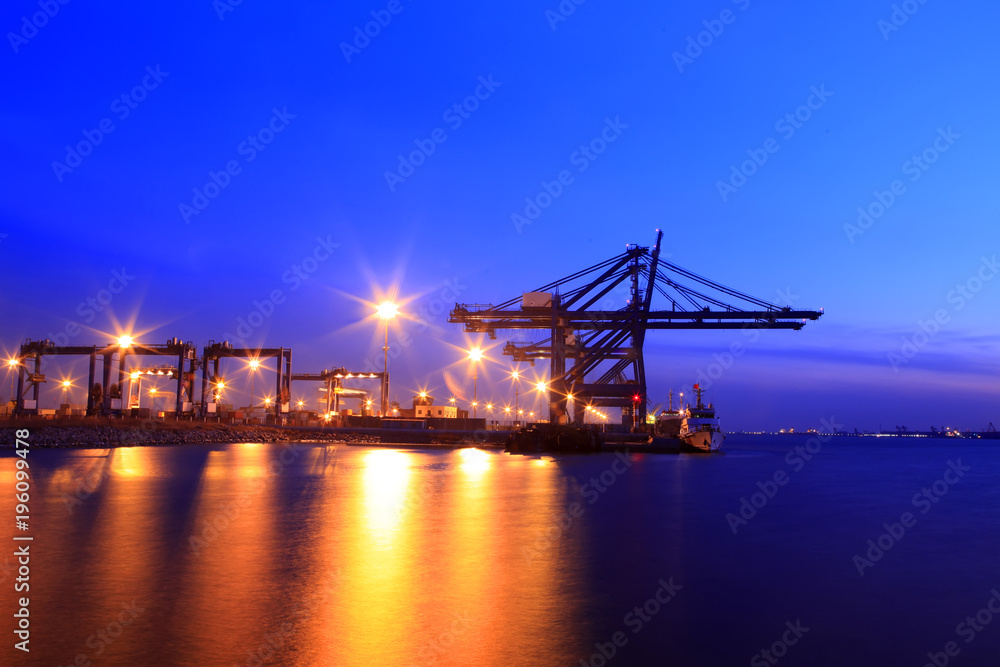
[[0, 421, 380, 447]]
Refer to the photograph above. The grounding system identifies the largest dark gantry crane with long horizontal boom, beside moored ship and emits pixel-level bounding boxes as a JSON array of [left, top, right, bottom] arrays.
[[448, 230, 823, 423]]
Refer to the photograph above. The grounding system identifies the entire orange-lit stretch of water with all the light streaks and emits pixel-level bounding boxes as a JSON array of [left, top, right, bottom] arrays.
[[25, 444, 588, 667]]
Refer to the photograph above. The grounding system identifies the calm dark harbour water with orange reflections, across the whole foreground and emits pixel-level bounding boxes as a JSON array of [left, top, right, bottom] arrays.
[[0, 436, 1000, 667]]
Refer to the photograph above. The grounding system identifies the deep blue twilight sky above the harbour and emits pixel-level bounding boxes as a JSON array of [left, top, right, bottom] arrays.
[[0, 0, 1000, 429]]
